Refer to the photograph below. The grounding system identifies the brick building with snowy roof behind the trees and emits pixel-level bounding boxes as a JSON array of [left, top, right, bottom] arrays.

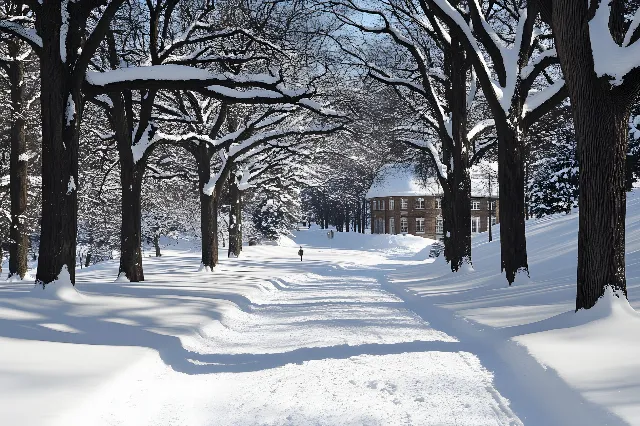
[[367, 165, 499, 239]]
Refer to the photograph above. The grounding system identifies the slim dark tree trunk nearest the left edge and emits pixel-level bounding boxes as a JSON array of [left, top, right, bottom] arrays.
[[8, 41, 29, 278]]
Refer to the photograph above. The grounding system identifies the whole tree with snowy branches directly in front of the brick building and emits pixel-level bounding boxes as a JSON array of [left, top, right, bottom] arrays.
[[328, 0, 493, 272]]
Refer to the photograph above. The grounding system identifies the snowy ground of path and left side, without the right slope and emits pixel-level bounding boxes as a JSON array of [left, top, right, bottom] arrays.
[[5, 232, 623, 426]]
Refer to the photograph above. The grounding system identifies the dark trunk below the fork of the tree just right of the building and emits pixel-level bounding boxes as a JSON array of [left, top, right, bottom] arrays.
[[496, 122, 529, 285]]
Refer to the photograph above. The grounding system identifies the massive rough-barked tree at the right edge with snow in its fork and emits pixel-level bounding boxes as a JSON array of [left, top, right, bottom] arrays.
[[540, 0, 640, 310]]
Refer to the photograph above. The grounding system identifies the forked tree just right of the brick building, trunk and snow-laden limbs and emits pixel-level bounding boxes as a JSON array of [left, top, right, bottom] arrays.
[[420, 0, 566, 284]]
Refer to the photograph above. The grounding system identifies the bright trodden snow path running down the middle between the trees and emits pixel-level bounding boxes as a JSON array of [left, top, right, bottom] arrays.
[[43, 236, 521, 426]]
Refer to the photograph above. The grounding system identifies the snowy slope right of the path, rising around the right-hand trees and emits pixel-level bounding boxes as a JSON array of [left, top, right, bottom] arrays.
[[388, 190, 640, 425]]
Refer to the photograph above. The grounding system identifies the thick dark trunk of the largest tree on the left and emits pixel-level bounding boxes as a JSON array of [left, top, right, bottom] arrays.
[[36, 5, 82, 284]]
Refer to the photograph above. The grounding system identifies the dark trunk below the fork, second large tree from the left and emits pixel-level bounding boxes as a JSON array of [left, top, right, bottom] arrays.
[[119, 166, 144, 282]]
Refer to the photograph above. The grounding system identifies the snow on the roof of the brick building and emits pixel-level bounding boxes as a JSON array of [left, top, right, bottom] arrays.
[[366, 163, 498, 198]]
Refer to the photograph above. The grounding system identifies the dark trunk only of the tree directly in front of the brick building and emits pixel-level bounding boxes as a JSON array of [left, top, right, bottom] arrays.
[[442, 37, 471, 272]]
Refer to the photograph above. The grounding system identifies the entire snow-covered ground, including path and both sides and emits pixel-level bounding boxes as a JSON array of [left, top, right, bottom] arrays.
[[0, 193, 640, 426]]
